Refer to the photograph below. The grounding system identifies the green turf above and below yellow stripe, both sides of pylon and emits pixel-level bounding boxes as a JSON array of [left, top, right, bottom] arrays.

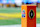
[[0, 8, 40, 25]]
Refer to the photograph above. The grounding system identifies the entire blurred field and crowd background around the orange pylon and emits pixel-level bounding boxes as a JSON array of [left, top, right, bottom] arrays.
[[0, 0, 40, 27]]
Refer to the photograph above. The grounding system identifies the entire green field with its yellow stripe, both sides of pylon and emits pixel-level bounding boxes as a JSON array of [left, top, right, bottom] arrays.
[[0, 8, 40, 25]]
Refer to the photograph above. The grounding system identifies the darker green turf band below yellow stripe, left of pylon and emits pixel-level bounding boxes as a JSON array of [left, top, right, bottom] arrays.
[[0, 18, 21, 25]]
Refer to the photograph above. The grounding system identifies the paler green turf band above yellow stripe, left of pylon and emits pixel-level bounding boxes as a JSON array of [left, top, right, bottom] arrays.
[[0, 8, 21, 13]]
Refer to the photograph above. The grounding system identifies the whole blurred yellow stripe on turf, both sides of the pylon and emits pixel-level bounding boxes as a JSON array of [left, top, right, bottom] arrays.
[[0, 13, 40, 19]]
